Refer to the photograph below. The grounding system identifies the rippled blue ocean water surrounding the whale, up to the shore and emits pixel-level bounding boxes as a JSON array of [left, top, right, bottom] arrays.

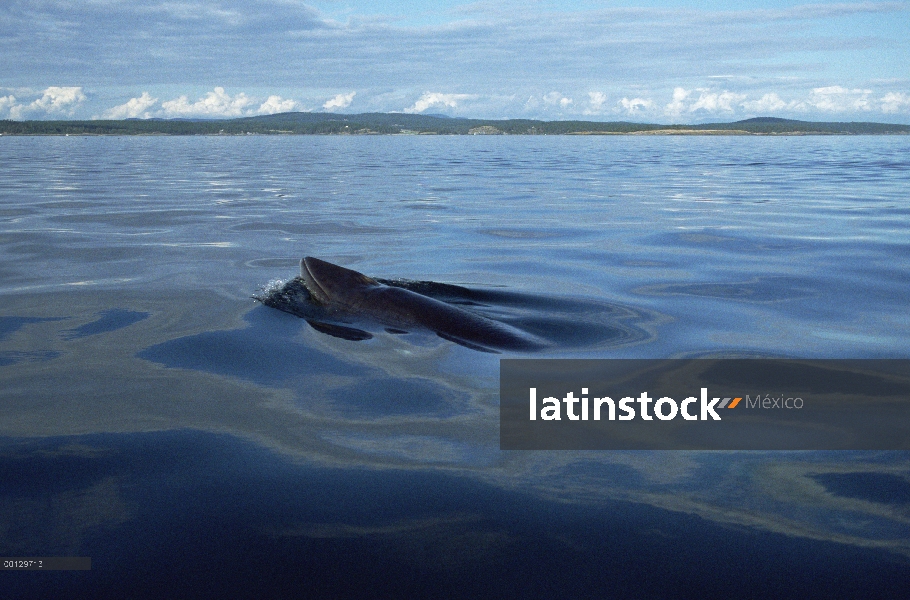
[[0, 136, 910, 598]]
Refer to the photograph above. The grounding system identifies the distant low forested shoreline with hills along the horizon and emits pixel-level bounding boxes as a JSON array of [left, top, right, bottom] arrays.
[[0, 113, 910, 136]]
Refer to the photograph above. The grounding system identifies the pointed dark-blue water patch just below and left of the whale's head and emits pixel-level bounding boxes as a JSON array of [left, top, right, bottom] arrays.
[[136, 307, 365, 385]]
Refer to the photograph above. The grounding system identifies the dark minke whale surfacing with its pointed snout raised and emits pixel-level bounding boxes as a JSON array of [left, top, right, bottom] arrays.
[[258, 256, 548, 352]]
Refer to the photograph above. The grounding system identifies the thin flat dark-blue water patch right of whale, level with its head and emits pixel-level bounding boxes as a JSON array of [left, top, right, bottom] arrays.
[[633, 277, 818, 302]]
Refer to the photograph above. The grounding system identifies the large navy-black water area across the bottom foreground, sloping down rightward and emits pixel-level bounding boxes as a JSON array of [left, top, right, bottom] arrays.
[[0, 430, 910, 600]]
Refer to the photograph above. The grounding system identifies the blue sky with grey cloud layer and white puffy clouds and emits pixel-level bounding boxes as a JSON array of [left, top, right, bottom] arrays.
[[0, 0, 910, 124]]
